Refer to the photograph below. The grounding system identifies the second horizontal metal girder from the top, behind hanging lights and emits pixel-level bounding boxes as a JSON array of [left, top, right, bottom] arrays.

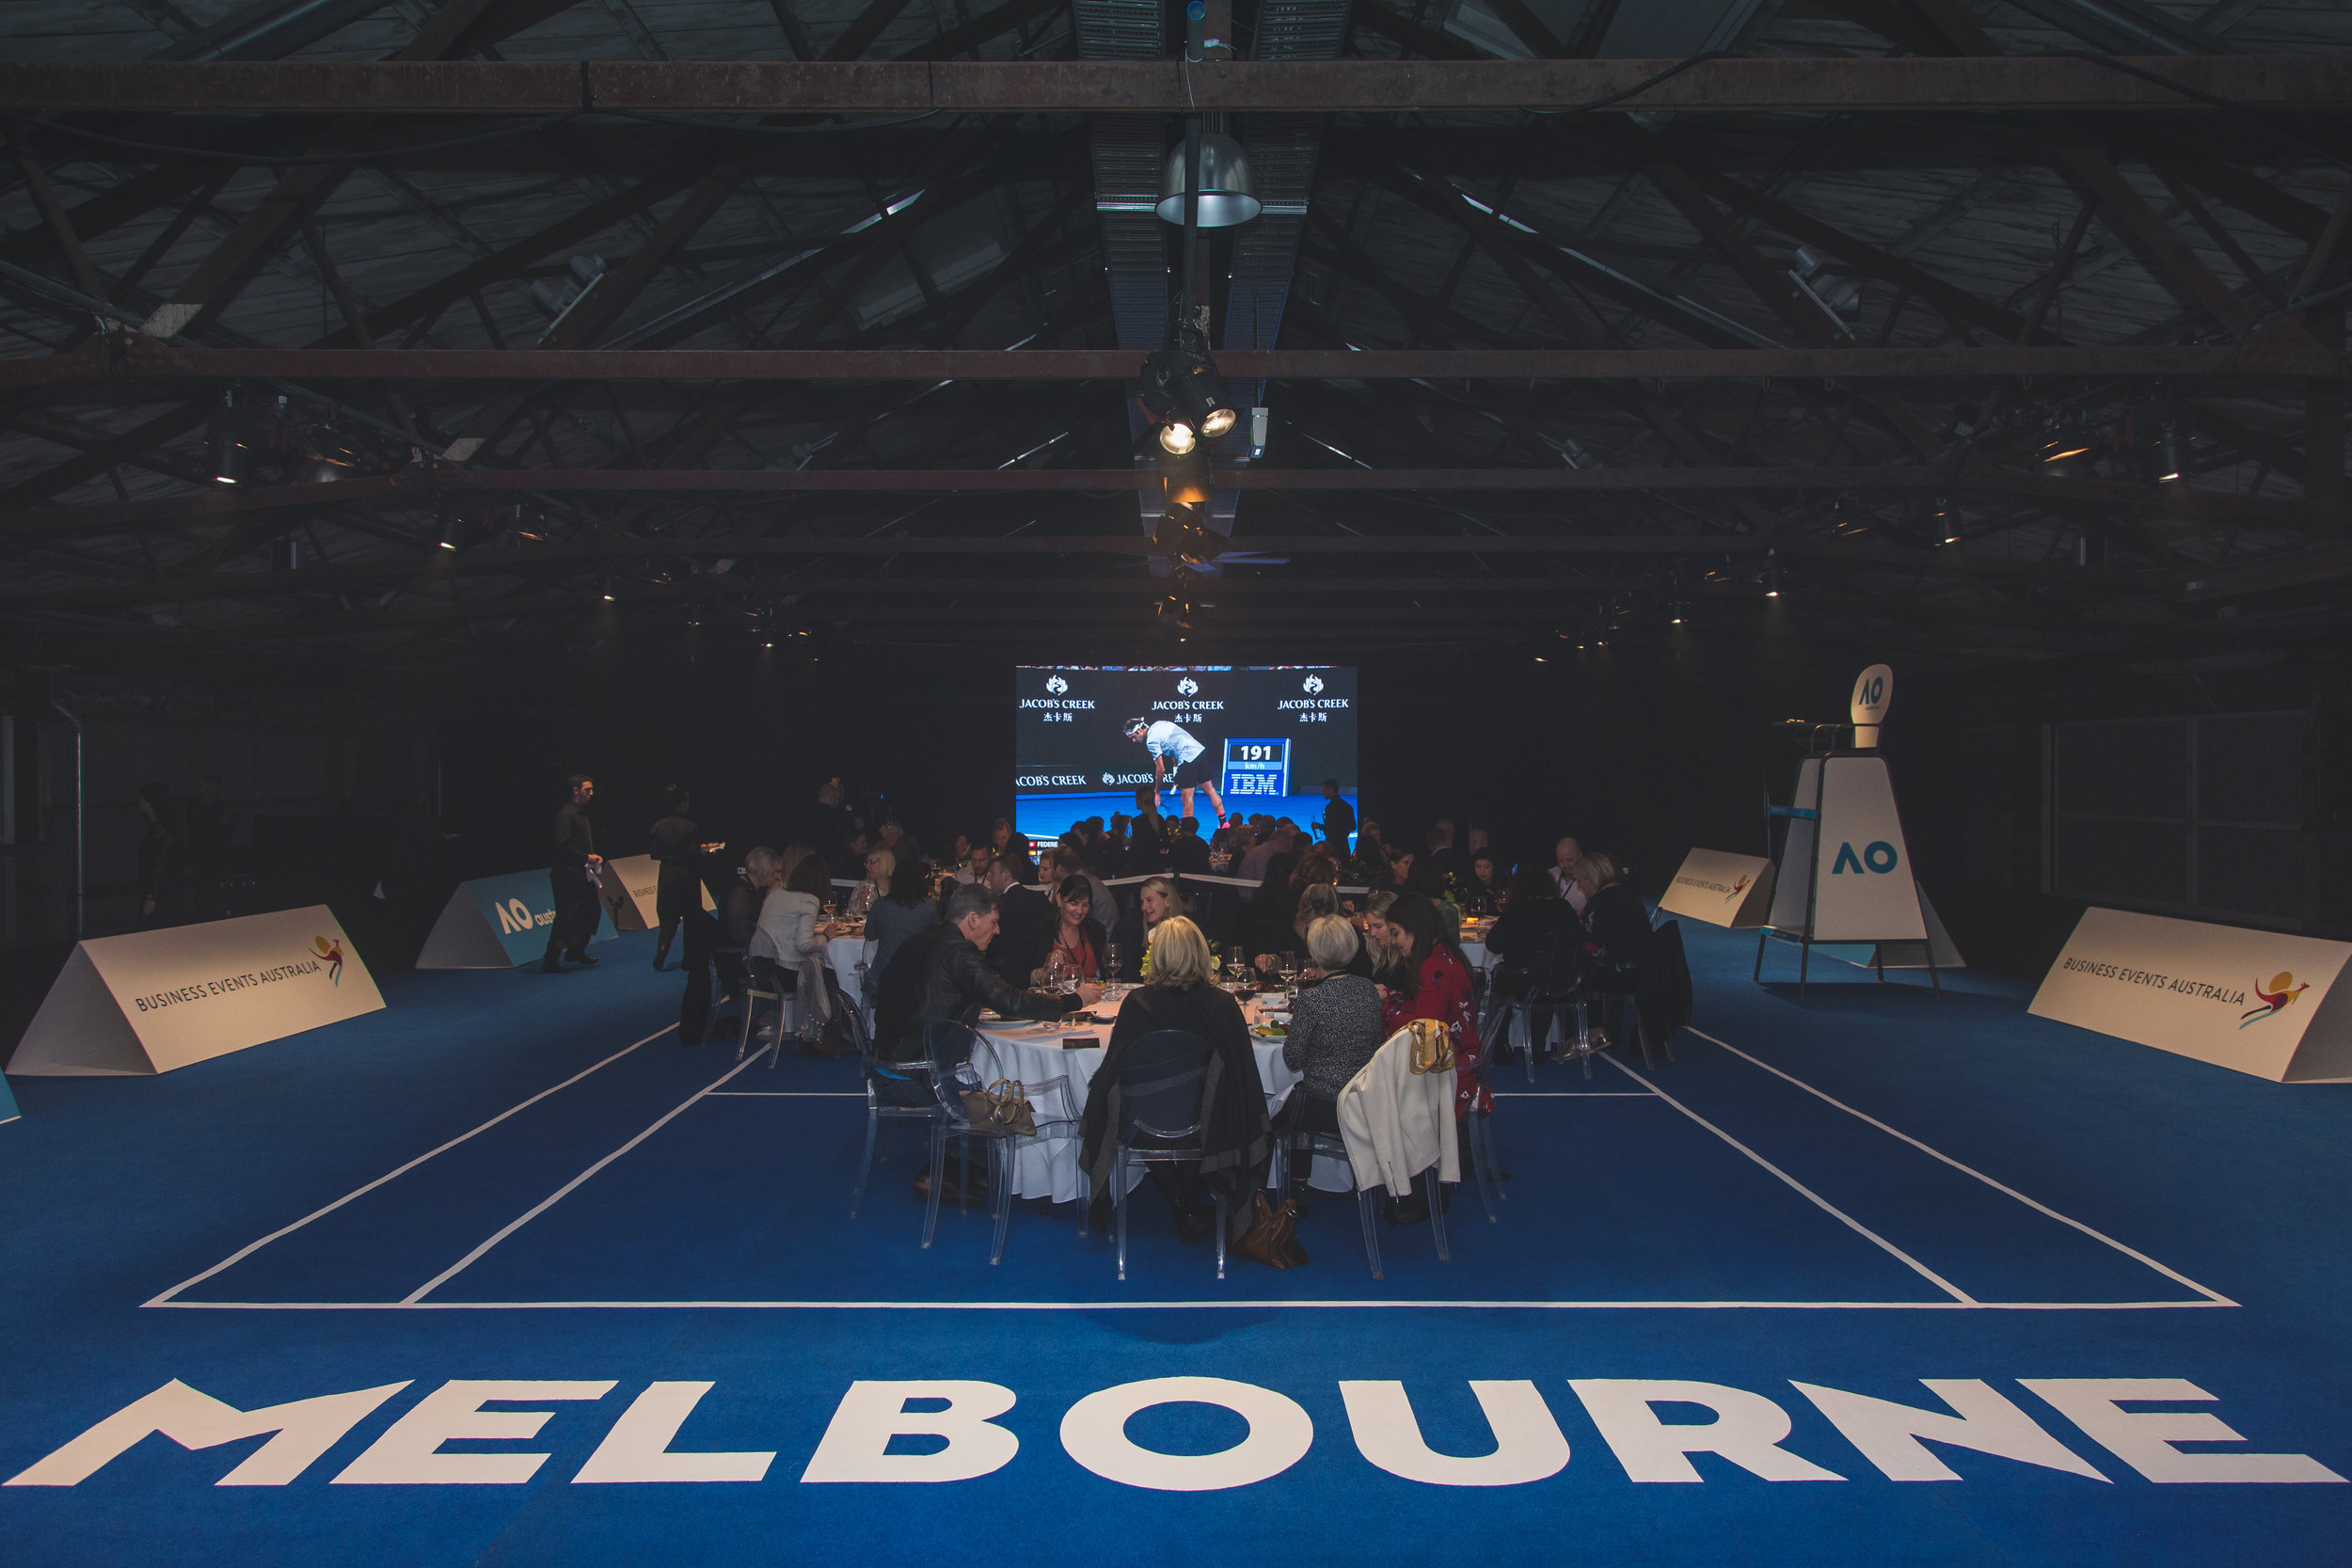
[[13, 341, 2345, 390]]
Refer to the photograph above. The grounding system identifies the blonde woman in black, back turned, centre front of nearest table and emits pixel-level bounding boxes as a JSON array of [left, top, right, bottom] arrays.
[[1080, 914, 1275, 1242]]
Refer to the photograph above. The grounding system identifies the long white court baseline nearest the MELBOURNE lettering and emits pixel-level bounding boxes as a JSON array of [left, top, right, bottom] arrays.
[[137, 1300, 2223, 1312]]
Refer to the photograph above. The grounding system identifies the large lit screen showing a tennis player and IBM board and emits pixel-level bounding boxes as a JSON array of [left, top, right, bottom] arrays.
[[1014, 665, 1358, 842]]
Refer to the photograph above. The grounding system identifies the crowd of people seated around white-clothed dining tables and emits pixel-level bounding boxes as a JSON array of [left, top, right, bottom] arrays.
[[548, 776, 1649, 1239]]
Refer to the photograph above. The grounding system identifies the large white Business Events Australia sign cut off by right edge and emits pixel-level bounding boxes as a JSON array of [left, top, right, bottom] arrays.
[[2030, 910, 2352, 1084]]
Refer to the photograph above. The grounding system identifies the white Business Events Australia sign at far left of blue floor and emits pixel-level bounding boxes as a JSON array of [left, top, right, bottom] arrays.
[[8, 905, 384, 1077]]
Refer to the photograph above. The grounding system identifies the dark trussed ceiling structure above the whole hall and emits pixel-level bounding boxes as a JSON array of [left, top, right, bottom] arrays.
[[0, 0, 2352, 693]]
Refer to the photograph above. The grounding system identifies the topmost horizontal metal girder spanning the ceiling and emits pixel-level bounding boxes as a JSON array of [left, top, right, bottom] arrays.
[[0, 54, 2352, 115]]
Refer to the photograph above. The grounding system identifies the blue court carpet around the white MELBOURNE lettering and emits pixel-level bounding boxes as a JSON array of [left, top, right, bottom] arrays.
[[0, 931, 2352, 1568]]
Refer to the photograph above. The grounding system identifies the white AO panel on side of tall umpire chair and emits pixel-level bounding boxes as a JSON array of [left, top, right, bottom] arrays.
[[1772, 757, 1927, 942]]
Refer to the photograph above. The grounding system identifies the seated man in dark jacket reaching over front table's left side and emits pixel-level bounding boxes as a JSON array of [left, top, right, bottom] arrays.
[[875, 886, 1104, 1204]]
